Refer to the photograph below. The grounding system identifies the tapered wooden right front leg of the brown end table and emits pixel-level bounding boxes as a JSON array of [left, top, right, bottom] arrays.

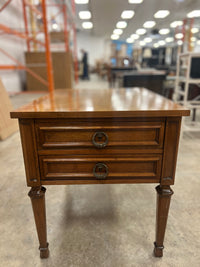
[[154, 185, 173, 257]]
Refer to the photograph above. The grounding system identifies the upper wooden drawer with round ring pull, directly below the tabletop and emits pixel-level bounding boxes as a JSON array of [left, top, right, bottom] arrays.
[[36, 120, 165, 151]]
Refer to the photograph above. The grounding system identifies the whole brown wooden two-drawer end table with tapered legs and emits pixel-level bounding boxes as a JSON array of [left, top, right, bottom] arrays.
[[11, 88, 189, 258]]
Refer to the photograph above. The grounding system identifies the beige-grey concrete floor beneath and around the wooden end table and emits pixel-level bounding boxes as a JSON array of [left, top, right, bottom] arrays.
[[0, 76, 200, 267]]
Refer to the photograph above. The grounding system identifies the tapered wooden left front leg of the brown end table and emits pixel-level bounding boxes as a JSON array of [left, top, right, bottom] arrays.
[[28, 187, 49, 258]]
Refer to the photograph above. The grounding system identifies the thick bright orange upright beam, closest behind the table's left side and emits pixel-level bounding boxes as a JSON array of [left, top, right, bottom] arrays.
[[42, 0, 54, 93]]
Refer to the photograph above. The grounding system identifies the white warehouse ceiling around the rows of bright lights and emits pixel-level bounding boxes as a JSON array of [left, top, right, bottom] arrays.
[[76, 0, 200, 40]]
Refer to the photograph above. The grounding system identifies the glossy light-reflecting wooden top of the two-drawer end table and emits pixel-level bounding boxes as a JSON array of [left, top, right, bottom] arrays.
[[11, 87, 190, 118]]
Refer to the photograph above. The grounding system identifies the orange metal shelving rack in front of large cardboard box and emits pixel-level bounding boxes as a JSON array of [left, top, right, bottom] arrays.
[[0, 0, 78, 92]]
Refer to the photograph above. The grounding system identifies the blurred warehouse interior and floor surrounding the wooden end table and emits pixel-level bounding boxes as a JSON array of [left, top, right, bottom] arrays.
[[0, 0, 200, 267]]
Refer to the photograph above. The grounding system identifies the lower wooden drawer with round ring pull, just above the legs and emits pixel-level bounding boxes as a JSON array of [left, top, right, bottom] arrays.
[[40, 154, 162, 182]]
